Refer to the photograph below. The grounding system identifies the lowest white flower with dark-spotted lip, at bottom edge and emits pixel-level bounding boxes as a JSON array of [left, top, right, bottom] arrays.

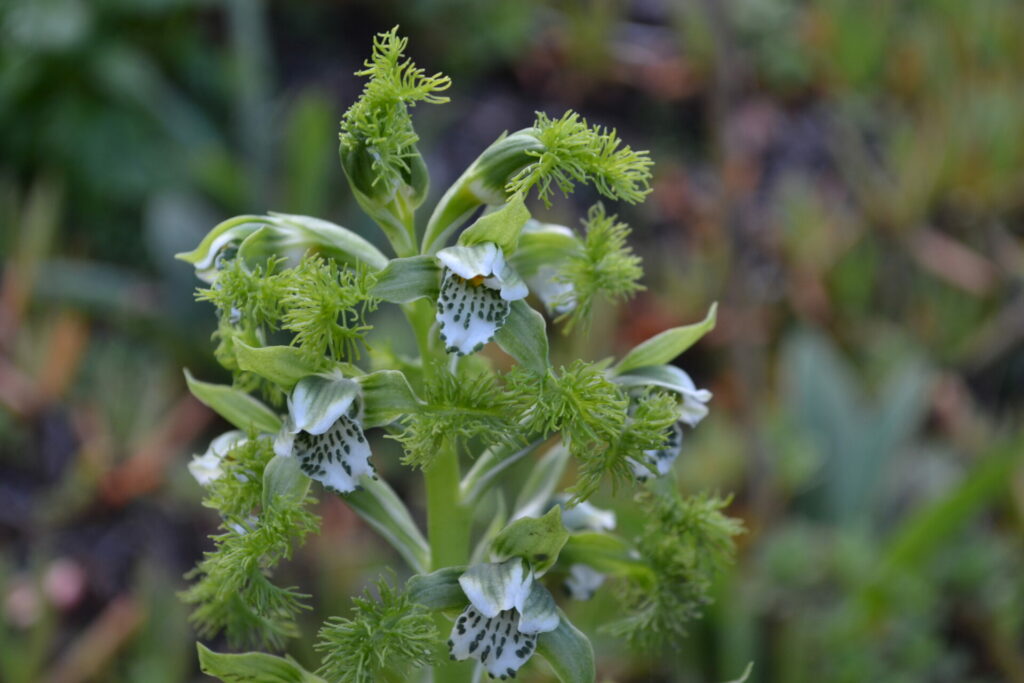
[[449, 558, 561, 680]]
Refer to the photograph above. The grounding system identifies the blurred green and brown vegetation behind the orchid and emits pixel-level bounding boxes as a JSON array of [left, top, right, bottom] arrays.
[[0, 0, 1024, 683]]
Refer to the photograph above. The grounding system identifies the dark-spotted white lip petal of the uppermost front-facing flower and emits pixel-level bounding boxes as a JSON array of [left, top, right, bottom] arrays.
[[435, 272, 510, 355]]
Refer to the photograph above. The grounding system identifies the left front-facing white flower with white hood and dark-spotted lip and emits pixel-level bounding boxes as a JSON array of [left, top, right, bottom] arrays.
[[273, 372, 377, 494]]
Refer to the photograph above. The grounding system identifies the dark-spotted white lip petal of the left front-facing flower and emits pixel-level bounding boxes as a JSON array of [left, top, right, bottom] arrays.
[[292, 416, 376, 494]]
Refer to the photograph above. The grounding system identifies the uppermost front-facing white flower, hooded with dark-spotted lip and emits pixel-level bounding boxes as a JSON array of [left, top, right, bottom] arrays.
[[436, 242, 528, 355]]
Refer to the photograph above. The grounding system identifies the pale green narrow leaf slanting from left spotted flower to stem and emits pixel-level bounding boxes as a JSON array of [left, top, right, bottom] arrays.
[[342, 477, 430, 573]]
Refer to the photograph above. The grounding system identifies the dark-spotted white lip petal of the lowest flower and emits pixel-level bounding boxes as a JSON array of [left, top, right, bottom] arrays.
[[449, 605, 537, 680]]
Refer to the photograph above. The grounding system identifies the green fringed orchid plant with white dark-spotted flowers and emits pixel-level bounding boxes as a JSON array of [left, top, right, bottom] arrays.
[[179, 31, 739, 683]]
